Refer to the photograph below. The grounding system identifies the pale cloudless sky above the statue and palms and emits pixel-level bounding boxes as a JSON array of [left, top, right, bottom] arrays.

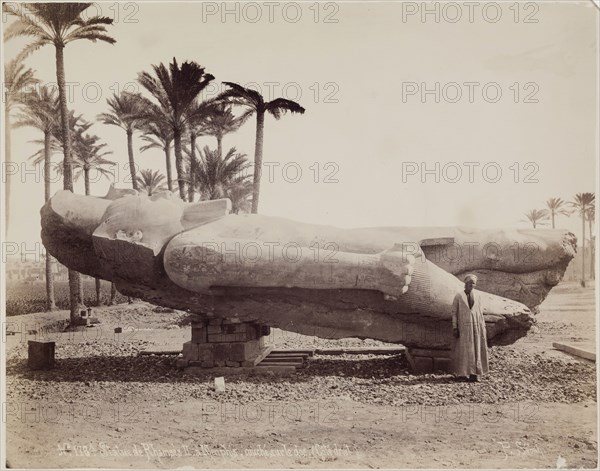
[[2, 1, 598, 254]]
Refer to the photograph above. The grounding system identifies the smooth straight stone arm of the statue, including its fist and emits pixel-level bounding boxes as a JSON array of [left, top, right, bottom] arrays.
[[164, 224, 422, 296]]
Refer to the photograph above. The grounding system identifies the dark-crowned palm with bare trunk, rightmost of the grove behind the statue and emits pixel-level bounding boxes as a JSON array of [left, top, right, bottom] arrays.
[[218, 82, 305, 214]]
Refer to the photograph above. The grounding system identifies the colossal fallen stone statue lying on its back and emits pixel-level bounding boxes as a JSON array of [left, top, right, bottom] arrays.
[[41, 188, 576, 372]]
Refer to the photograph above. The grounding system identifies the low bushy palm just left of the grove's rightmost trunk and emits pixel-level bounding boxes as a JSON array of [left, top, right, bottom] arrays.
[[197, 146, 250, 200]]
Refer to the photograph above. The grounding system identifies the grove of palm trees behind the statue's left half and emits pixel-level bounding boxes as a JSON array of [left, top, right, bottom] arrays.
[[3, 3, 304, 323]]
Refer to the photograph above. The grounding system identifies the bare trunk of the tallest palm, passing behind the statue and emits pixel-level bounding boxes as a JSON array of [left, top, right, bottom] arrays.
[[55, 44, 83, 325]]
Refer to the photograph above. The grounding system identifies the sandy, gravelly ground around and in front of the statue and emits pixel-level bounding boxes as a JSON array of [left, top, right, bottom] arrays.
[[3, 283, 598, 468]]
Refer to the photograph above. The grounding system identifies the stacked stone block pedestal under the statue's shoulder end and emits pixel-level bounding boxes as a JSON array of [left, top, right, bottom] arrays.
[[177, 319, 273, 368]]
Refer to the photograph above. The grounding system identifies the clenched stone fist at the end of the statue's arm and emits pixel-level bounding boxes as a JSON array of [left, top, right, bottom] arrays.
[[379, 244, 415, 301]]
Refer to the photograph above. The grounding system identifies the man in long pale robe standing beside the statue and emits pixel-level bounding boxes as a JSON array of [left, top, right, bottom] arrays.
[[452, 275, 488, 382]]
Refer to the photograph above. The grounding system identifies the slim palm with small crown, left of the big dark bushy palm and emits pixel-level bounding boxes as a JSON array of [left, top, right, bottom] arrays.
[[98, 92, 143, 190]]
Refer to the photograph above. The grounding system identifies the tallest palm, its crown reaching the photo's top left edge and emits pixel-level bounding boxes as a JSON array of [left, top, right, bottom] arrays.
[[2, 2, 116, 325]]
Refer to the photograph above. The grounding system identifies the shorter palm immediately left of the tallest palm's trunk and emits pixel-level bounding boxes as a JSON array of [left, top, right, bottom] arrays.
[[14, 87, 59, 311]]
